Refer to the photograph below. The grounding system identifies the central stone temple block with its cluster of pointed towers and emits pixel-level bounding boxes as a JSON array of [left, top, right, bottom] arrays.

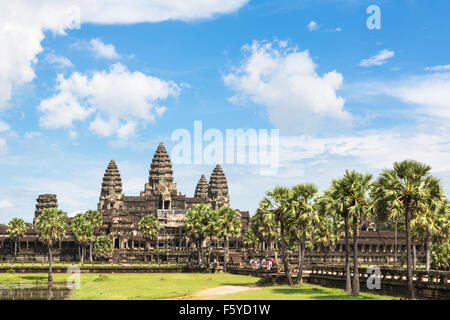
[[98, 142, 236, 249]]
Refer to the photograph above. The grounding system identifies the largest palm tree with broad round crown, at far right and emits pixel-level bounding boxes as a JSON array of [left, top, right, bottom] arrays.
[[373, 160, 434, 299]]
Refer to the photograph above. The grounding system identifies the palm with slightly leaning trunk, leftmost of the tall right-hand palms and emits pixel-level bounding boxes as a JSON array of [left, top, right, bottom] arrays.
[[259, 186, 294, 286]]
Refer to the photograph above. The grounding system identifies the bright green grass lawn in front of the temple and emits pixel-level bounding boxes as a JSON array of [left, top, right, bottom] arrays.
[[0, 273, 394, 300]]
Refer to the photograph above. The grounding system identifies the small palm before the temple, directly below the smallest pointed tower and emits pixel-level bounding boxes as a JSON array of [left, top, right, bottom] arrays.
[[184, 203, 212, 265]]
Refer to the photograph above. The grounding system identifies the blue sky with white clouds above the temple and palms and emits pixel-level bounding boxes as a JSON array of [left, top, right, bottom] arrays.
[[0, 0, 450, 223]]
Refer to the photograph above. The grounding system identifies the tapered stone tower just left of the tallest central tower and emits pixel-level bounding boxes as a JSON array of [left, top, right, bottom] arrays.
[[98, 160, 123, 210]]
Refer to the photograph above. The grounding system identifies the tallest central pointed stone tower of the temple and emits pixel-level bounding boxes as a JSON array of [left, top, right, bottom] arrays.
[[141, 142, 180, 209]]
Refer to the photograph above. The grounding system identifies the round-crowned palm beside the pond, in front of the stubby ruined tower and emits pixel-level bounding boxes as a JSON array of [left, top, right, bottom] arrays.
[[36, 208, 67, 282]]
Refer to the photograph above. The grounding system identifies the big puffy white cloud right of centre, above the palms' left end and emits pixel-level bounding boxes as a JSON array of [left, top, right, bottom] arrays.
[[223, 41, 351, 131]]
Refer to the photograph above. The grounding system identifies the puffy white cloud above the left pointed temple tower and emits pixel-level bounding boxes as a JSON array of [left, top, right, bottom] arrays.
[[38, 63, 181, 139]]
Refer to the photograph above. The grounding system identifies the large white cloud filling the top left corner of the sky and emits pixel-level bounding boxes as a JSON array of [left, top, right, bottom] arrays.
[[0, 0, 248, 108]]
